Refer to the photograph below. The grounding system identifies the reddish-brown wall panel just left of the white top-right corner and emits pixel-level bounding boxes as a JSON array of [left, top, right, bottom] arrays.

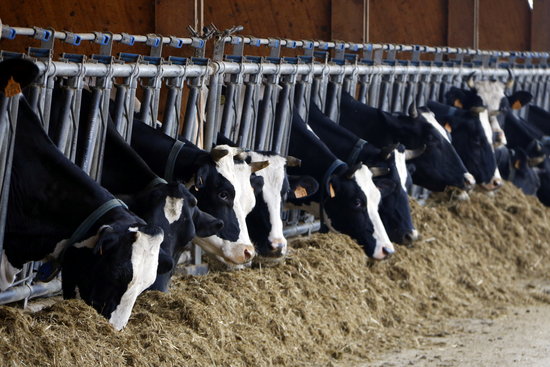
[[479, 0, 532, 50]]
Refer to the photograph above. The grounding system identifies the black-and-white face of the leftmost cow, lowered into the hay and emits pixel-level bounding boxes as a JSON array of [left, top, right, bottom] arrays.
[[62, 226, 164, 330]]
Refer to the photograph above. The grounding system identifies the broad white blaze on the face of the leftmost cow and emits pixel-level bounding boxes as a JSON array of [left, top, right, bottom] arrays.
[[109, 231, 164, 330]]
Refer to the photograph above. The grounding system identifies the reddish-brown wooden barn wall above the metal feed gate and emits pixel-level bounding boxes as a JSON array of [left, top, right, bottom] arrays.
[[0, 0, 550, 54]]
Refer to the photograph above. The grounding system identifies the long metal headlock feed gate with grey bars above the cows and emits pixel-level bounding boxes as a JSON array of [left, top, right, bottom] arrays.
[[0, 23, 550, 304]]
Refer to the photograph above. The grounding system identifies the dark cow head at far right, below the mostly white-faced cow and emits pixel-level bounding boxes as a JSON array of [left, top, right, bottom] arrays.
[[495, 146, 540, 195]]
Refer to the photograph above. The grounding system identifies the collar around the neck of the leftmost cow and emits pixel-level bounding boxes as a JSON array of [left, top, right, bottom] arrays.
[[36, 199, 128, 282]]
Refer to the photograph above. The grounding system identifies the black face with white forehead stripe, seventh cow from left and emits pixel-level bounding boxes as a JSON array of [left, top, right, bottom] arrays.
[[399, 110, 472, 191]]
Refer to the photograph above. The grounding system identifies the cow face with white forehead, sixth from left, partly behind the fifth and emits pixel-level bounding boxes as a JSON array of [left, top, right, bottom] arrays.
[[373, 145, 418, 245]]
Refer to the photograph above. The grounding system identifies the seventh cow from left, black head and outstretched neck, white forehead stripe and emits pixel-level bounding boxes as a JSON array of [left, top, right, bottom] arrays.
[[339, 92, 475, 191]]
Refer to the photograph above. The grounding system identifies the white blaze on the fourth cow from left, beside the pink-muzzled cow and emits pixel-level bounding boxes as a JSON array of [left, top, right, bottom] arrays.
[[249, 152, 287, 256]]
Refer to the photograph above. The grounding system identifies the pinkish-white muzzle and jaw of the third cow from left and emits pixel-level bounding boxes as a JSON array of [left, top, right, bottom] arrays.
[[193, 236, 256, 265]]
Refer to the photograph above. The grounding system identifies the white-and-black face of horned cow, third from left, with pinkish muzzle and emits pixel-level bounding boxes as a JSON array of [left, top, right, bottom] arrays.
[[195, 145, 266, 264]]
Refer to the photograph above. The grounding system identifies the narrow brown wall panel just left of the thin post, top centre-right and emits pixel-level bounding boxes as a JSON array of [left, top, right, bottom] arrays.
[[330, 0, 367, 42]]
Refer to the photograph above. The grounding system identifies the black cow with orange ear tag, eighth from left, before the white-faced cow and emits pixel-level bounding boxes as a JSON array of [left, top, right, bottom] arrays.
[[428, 100, 497, 188]]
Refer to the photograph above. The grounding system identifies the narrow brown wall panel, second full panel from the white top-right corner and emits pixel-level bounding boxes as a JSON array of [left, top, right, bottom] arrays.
[[447, 0, 476, 48]]
